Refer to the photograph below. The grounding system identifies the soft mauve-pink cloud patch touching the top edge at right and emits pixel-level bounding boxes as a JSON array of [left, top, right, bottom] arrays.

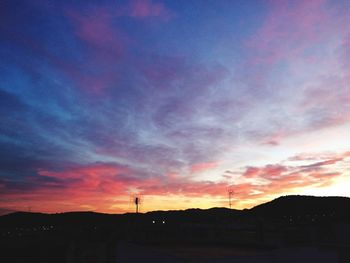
[[248, 0, 331, 64]]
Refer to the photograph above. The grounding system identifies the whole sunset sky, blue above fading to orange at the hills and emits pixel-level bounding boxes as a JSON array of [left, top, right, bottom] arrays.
[[0, 0, 350, 214]]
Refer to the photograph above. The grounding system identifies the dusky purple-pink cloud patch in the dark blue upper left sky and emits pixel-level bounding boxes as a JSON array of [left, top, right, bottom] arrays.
[[65, 8, 128, 94]]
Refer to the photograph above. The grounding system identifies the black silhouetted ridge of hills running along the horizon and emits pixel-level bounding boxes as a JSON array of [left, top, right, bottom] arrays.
[[0, 195, 350, 226]]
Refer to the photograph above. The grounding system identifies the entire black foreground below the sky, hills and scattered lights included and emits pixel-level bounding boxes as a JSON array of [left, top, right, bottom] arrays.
[[0, 196, 350, 263]]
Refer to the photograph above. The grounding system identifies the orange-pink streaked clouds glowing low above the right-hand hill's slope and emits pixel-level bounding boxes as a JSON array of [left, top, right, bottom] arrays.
[[220, 152, 347, 205]]
